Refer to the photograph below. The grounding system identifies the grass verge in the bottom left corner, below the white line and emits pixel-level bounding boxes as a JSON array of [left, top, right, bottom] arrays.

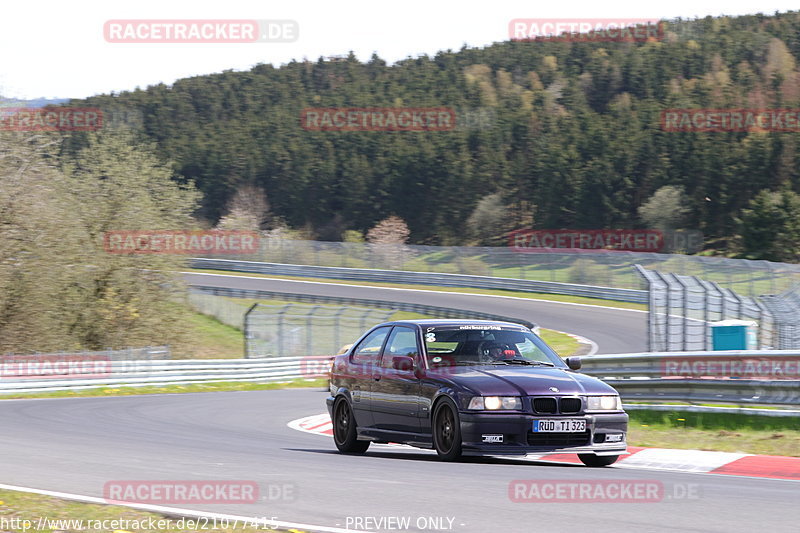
[[0, 490, 302, 533]]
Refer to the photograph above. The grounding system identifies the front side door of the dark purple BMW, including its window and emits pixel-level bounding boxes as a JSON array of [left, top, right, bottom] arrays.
[[370, 326, 421, 433]]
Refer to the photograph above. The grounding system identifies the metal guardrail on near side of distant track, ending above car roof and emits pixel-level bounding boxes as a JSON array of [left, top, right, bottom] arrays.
[[191, 285, 538, 333]]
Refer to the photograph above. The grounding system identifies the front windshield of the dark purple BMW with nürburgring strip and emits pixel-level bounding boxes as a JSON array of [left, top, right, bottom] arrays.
[[423, 325, 566, 368]]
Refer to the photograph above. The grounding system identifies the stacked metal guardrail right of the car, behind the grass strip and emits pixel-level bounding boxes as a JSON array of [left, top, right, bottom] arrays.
[[581, 350, 800, 406]]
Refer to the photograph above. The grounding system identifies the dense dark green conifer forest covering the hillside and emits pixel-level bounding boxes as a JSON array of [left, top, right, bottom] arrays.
[[64, 12, 800, 261]]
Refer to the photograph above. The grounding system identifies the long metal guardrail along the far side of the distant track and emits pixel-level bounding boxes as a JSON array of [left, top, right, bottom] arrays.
[[190, 258, 647, 303]]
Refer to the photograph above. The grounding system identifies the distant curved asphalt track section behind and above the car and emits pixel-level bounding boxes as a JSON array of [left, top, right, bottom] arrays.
[[184, 272, 647, 353]]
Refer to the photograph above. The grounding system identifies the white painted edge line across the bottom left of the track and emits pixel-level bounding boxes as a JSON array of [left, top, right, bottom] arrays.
[[0, 484, 370, 533]]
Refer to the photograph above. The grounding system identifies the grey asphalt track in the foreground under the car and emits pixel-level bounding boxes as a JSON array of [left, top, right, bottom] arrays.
[[0, 389, 800, 533]]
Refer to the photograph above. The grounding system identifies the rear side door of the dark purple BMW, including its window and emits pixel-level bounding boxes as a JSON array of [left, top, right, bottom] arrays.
[[345, 326, 392, 428]]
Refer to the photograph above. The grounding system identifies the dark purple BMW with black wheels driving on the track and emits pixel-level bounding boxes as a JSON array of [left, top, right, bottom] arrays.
[[327, 320, 628, 466]]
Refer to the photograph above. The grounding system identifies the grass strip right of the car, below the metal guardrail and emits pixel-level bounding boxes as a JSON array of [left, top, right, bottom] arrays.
[[628, 410, 800, 457]]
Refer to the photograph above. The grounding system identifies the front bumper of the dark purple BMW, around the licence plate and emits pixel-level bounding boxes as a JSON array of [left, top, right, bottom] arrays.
[[460, 411, 628, 455]]
